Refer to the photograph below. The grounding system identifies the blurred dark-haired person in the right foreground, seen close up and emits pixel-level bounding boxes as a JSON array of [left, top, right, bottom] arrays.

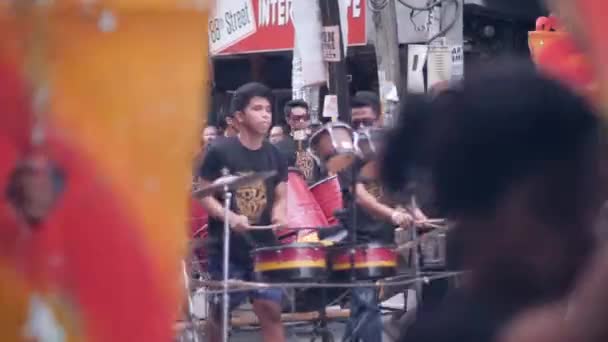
[[384, 60, 602, 342]]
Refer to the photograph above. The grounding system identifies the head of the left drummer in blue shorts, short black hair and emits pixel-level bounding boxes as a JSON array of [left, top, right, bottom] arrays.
[[230, 82, 272, 136]]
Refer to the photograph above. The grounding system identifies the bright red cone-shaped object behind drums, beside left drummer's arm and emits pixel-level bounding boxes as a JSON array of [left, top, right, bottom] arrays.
[[277, 168, 328, 243]]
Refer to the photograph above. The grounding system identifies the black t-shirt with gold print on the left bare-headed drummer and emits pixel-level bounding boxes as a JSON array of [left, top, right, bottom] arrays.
[[200, 137, 287, 264]]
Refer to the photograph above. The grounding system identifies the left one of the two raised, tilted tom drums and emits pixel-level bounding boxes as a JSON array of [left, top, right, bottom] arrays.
[[309, 122, 356, 173]]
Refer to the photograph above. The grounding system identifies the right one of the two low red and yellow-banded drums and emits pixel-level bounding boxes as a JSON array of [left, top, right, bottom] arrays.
[[328, 243, 397, 280]]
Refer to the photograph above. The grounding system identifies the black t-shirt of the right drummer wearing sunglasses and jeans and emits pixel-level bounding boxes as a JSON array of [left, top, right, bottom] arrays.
[[338, 161, 395, 244]]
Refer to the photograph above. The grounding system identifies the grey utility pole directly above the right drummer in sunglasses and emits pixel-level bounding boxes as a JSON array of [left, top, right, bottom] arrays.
[[368, 0, 404, 124]]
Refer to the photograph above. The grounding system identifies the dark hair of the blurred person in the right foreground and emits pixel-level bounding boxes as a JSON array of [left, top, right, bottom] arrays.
[[383, 58, 600, 218]]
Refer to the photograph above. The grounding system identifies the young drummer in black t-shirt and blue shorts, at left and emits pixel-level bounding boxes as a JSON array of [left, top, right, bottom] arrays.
[[201, 83, 287, 342]]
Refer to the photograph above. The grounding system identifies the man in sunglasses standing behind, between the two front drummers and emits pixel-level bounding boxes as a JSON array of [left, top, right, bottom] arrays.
[[275, 100, 320, 184]]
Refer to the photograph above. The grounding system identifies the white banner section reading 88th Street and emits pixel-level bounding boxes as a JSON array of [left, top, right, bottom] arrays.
[[209, 0, 257, 54]]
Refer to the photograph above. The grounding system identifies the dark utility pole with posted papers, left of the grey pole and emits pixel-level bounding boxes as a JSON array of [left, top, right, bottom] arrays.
[[319, 0, 351, 124]]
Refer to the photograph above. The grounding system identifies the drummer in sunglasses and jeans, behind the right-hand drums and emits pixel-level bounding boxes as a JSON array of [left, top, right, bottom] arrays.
[[340, 91, 420, 342]]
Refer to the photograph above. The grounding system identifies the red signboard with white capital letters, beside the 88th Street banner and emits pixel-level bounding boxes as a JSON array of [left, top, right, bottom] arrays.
[[210, 0, 367, 55]]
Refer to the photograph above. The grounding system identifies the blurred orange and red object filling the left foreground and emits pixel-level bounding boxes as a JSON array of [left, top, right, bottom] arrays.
[[0, 0, 208, 342]]
